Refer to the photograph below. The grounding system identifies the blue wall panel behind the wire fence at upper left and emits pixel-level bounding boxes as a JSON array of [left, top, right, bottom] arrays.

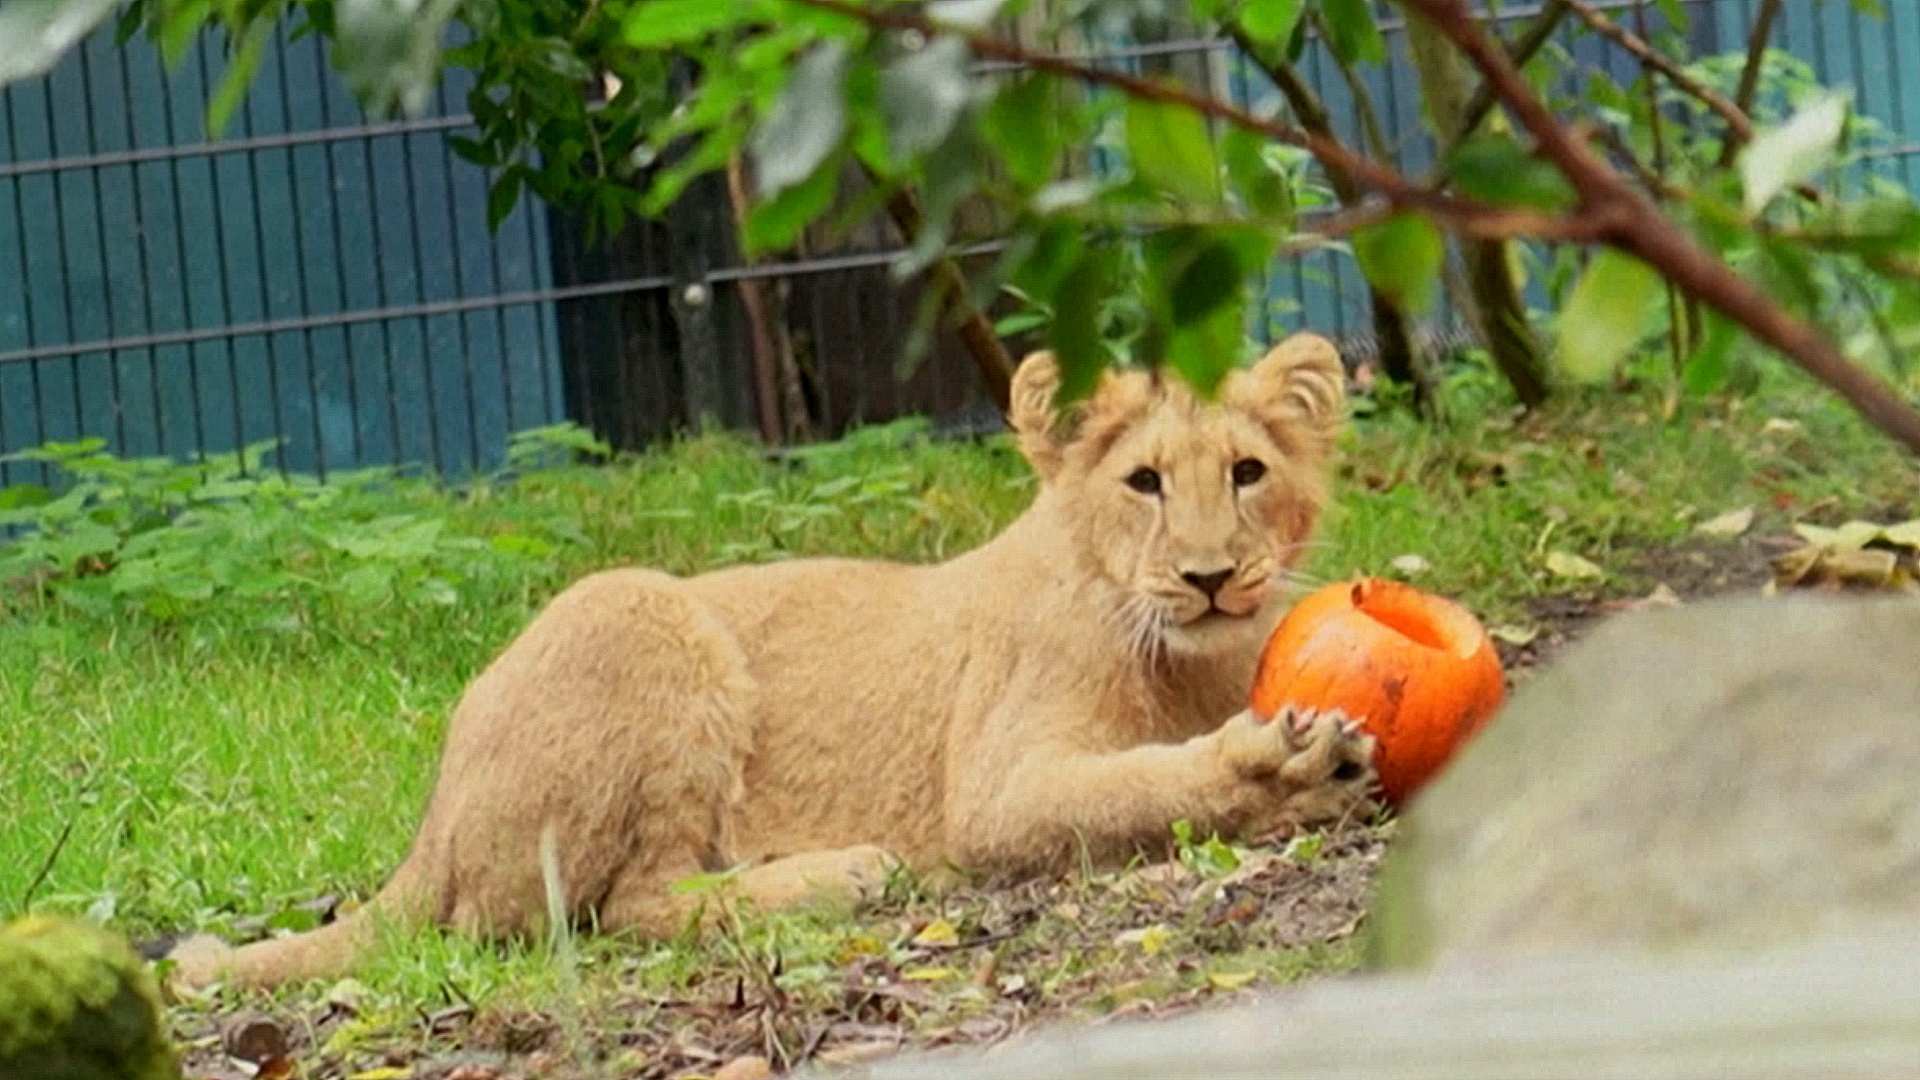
[[0, 15, 564, 482]]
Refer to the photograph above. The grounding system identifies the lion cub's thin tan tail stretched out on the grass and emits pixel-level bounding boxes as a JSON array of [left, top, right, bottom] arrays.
[[167, 853, 428, 988]]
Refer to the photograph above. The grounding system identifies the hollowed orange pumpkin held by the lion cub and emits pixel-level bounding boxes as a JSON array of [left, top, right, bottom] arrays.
[[1252, 578, 1505, 805]]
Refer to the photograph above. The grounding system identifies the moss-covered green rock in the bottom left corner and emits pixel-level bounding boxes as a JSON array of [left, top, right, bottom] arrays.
[[0, 917, 180, 1080]]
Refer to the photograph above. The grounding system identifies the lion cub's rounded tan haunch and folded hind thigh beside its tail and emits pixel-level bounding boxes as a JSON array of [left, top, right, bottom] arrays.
[[419, 571, 755, 936]]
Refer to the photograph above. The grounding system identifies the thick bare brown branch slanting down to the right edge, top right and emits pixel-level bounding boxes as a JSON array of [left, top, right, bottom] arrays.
[[1400, 0, 1920, 454]]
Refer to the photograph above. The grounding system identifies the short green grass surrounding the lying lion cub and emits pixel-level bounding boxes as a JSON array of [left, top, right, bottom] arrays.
[[0, 374, 1916, 1068]]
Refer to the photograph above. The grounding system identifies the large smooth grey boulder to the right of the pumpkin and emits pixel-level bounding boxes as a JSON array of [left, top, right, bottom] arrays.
[[1369, 598, 1920, 969]]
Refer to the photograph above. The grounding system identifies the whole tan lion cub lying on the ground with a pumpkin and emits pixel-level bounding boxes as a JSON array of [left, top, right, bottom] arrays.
[[177, 334, 1369, 984]]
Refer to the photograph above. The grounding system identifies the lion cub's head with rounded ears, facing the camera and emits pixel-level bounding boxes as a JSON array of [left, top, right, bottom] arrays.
[[1010, 334, 1346, 651]]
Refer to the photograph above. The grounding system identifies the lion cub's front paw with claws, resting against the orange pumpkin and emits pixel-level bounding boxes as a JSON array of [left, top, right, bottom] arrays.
[[1219, 709, 1375, 832]]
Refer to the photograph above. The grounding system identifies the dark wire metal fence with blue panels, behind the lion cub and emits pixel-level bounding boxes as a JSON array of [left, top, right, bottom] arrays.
[[0, 0, 1920, 484]]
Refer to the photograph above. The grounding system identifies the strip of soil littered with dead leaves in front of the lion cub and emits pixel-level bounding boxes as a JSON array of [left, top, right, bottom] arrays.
[[175, 822, 1386, 1080]]
